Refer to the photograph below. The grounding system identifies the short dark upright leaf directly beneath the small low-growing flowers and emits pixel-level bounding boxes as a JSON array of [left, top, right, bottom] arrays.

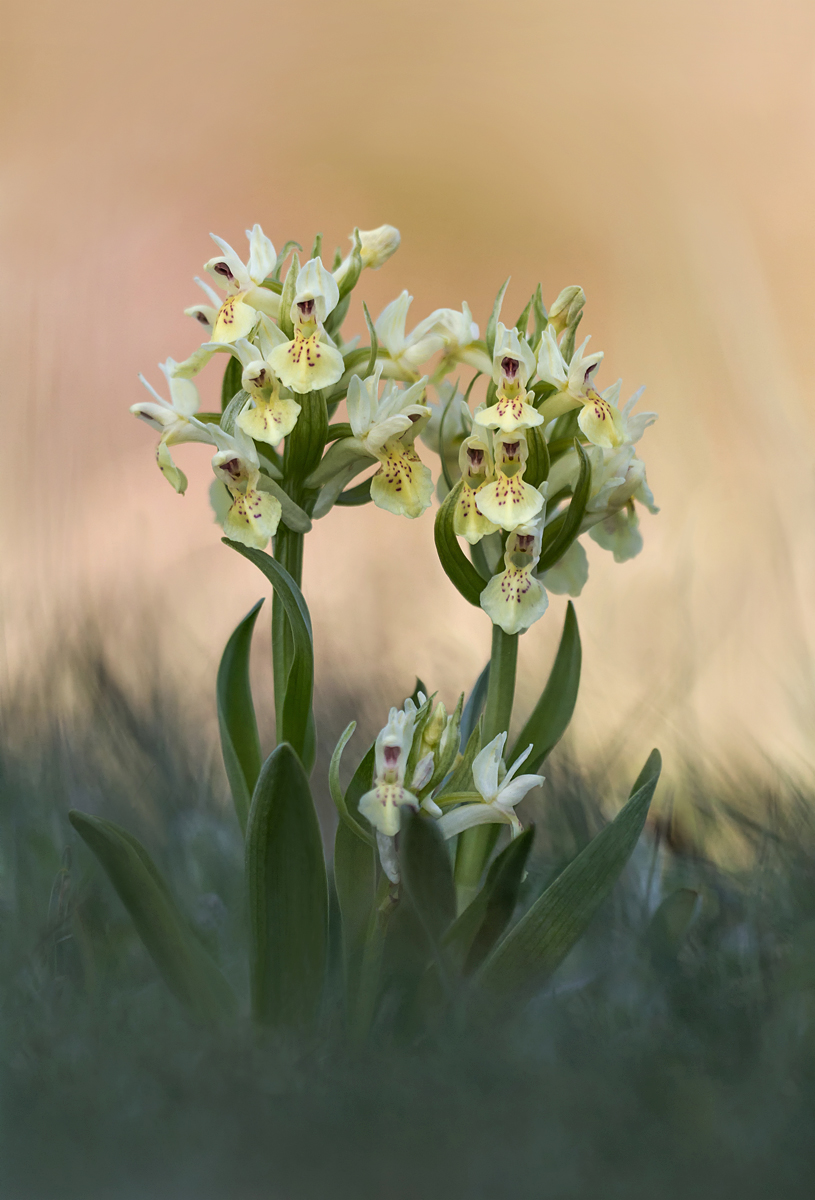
[[398, 811, 456, 947]]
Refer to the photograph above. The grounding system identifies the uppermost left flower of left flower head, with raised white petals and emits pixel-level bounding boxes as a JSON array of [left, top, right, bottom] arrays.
[[200, 224, 280, 343]]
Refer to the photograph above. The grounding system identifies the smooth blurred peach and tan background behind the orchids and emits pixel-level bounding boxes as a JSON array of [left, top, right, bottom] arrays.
[[0, 0, 815, 772]]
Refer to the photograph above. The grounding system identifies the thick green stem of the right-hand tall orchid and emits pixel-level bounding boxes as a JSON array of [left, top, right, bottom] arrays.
[[455, 625, 517, 911]]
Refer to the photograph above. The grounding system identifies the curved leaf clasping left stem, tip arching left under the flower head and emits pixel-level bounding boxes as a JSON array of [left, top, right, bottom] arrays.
[[221, 538, 314, 768]]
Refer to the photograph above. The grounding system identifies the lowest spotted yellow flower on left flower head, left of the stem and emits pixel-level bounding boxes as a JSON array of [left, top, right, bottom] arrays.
[[206, 408, 282, 550]]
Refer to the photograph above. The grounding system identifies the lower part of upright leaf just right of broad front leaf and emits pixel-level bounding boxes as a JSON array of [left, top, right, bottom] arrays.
[[334, 821, 377, 1013]]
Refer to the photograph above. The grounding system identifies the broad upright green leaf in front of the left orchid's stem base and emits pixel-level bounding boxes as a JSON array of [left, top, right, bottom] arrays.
[[246, 742, 328, 1026]]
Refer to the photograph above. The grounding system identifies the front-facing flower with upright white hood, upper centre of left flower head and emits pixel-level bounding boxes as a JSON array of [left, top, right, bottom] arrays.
[[269, 258, 344, 395]]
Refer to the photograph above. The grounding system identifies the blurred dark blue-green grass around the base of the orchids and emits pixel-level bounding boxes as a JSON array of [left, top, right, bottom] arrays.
[[0, 635, 815, 1200]]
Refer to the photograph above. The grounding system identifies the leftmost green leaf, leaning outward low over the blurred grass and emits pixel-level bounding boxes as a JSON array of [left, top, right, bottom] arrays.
[[68, 809, 236, 1021]]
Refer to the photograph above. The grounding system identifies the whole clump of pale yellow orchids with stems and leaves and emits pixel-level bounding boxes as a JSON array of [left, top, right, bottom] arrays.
[[71, 224, 659, 1034]]
